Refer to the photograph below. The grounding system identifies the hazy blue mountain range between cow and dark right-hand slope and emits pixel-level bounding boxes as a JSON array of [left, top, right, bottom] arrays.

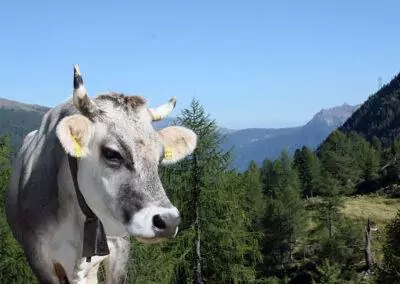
[[222, 103, 360, 171]]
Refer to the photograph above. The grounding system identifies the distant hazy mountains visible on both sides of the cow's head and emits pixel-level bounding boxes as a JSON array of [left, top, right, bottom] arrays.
[[0, 96, 359, 171]]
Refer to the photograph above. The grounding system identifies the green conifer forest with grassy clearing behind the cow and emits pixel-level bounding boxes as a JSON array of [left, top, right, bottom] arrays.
[[0, 100, 400, 284]]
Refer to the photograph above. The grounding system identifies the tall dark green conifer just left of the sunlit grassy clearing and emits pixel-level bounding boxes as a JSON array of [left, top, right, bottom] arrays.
[[263, 151, 305, 270]]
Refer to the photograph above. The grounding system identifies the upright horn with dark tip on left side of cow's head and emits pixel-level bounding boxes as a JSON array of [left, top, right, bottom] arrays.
[[72, 64, 97, 117]]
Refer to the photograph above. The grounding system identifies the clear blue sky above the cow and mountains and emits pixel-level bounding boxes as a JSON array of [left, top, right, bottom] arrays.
[[0, 0, 400, 128]]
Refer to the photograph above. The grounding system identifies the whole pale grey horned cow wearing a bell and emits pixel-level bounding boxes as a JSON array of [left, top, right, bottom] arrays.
[[5, 65, 198, 283]]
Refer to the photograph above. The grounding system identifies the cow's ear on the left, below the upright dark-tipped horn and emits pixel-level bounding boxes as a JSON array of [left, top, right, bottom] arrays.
[[56, 114, 92, 158]]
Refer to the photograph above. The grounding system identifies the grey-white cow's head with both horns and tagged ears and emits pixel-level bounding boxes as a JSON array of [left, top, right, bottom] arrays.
[[57, 65, 197, 242]]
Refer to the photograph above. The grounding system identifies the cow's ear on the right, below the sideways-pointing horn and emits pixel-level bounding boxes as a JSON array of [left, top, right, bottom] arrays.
[[158, 126, 197, 165]]
